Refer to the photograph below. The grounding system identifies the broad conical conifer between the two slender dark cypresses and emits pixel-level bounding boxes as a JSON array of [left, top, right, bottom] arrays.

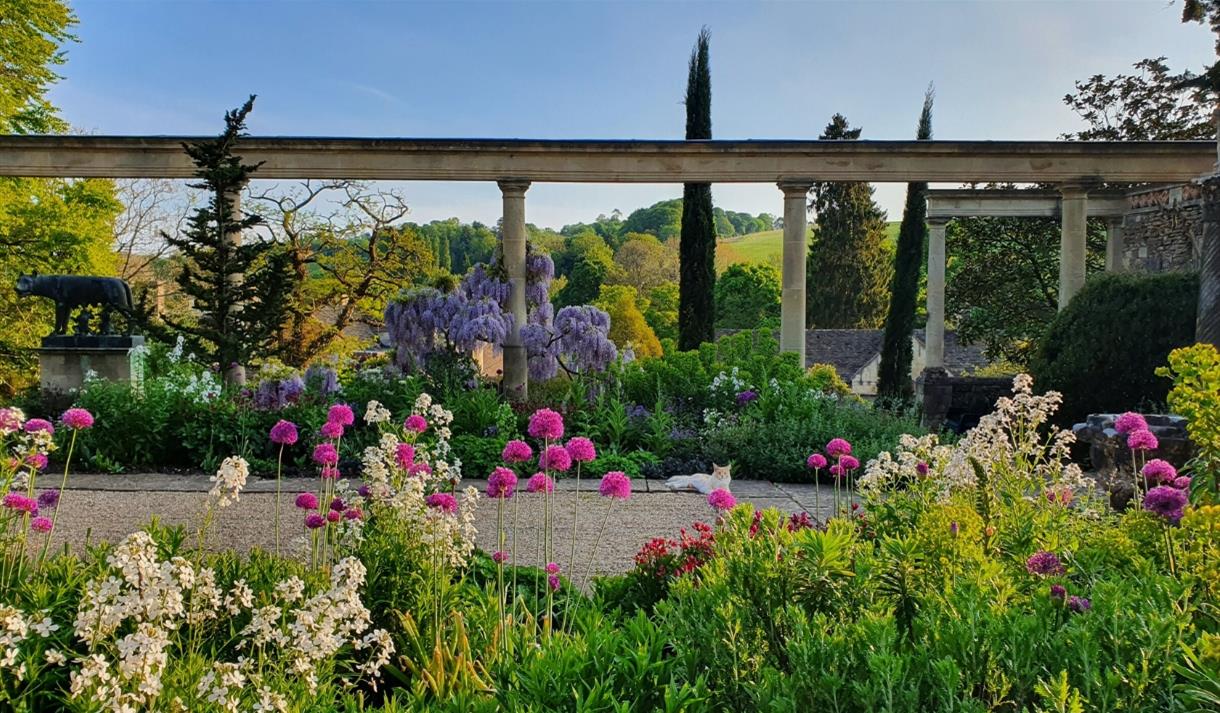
[[806, 114, 892, 328]]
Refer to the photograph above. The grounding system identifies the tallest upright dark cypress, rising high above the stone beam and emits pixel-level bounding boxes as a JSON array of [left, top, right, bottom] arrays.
[[678, 27, 716, 349]]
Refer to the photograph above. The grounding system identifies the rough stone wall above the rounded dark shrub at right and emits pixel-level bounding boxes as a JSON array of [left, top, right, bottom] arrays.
[[1122, 183, 1203, 272]]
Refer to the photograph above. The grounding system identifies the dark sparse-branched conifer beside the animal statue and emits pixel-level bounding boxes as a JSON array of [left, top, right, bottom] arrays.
[[163, 95, 292, 383]]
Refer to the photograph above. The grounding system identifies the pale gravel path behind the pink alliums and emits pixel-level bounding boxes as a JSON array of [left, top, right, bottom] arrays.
[[38, 474, 832, 574]]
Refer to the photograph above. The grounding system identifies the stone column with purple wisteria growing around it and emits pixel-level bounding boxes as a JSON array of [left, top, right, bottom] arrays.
[[499, 178, 529, 400]]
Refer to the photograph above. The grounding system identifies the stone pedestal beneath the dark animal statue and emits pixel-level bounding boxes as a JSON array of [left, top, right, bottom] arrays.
[[38, 335, 144, 393]]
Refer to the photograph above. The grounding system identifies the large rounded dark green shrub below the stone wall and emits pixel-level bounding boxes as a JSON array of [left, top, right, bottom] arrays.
[[1030, 272, 1199, 425]]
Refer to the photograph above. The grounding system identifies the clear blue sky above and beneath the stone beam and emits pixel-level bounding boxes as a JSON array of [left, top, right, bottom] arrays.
[[51, 0, 1214, 227]]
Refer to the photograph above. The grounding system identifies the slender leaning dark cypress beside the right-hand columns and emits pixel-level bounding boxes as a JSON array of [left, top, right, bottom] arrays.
[[877, 85, 935, 404]]
